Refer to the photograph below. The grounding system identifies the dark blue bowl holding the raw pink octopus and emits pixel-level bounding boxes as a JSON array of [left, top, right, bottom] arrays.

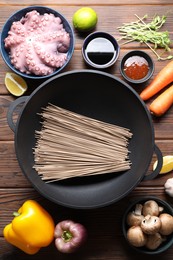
[[0, 6, 74, 79]]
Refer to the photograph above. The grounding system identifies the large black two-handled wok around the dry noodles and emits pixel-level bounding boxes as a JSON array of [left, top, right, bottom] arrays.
[[8, 70, 162, 209]]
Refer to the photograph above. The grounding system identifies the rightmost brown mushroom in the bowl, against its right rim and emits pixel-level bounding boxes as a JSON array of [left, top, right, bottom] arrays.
[[159, 213, 173, 236]]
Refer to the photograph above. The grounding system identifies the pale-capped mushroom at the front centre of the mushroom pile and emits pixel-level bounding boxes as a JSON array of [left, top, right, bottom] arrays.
[[141, 215, 161, 235]]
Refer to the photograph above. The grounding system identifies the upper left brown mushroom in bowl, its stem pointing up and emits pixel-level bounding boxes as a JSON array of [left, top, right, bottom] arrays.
[[126, 204, 144, 227]]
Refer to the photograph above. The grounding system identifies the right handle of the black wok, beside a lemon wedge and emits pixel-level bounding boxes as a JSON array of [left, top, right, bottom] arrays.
[[143, 144, 163, 181]]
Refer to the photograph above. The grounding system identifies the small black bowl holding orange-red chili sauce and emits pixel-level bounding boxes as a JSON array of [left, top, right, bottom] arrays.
[[120, 50, 154, 84]]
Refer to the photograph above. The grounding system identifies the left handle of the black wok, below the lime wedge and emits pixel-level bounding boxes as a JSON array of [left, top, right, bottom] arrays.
[[7, 96, 28, 132]]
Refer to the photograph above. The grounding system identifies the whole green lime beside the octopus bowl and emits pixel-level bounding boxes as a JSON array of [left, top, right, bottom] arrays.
[[73, 7, 98, 32]]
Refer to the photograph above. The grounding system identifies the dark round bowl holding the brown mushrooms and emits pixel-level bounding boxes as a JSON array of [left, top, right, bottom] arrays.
[[122, 196, 173, 255]]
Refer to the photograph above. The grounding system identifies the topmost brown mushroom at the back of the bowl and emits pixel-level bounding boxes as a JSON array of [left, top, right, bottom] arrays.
[[142, 200, 163, 216]]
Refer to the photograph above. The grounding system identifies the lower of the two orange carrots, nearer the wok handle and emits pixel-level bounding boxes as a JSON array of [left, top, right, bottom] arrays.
[[149, 85, 173, 116]]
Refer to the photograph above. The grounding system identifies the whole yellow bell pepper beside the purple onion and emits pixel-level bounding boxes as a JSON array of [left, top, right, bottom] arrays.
[[3, 200, 55, 255]]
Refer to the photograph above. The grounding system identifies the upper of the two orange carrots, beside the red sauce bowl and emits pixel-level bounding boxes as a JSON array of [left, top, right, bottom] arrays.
[[140, 60, 173, 100]]
